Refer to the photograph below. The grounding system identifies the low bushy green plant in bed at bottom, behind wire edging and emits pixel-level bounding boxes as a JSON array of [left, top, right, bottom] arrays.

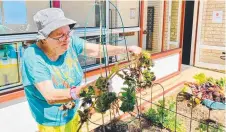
[[144, 100, 185, 132]]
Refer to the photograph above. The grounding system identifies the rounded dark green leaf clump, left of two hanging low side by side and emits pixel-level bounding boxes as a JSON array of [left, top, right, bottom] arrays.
[[95, 92, 117, 113]]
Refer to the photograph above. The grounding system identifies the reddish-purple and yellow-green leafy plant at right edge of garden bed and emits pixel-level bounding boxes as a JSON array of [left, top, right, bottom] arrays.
[[182, 73, 226, 104]]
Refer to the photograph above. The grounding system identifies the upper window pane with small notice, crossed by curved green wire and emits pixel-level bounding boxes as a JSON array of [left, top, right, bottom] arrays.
[[109, 0, 139, 28]]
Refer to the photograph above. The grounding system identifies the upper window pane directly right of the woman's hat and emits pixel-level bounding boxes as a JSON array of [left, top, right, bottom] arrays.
[[61, 0, 106, 27]]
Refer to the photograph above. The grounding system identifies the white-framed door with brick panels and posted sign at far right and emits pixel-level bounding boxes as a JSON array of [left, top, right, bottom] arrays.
[[195, 0, 226, 70]]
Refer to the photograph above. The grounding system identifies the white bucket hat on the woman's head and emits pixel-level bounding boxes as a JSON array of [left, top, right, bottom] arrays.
[[33, 8, 77, 40]]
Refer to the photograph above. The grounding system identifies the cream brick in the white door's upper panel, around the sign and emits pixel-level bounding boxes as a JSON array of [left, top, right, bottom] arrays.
[[201, 0, 226, 46]]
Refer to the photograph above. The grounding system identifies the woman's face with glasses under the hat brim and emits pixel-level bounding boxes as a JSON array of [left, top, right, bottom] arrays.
[[46, 26, 71, 55]]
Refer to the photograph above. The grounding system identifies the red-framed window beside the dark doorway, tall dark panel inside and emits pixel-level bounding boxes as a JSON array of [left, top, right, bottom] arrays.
[[145, 1, 182, 53]]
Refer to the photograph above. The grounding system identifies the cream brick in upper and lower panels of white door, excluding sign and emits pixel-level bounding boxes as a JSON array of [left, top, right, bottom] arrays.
[[199, 0, 226, 65]]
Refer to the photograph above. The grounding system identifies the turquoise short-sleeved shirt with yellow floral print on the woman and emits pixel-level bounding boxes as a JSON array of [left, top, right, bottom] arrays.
[[22, 36, 85, 126]]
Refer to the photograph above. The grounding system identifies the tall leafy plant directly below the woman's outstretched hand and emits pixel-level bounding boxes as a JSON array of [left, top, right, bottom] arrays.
[[117, 51, 155, 112]]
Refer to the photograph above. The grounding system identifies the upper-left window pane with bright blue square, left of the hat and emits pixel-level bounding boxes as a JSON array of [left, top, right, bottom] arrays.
[[0, 1, 50, 34]]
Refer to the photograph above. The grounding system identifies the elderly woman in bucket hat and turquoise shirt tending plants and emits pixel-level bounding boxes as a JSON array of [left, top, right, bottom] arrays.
[[22, 8, 141, 132]]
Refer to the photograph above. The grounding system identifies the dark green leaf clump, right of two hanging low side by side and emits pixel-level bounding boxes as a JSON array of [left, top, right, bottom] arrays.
[[120, 88, 136, 112]]
